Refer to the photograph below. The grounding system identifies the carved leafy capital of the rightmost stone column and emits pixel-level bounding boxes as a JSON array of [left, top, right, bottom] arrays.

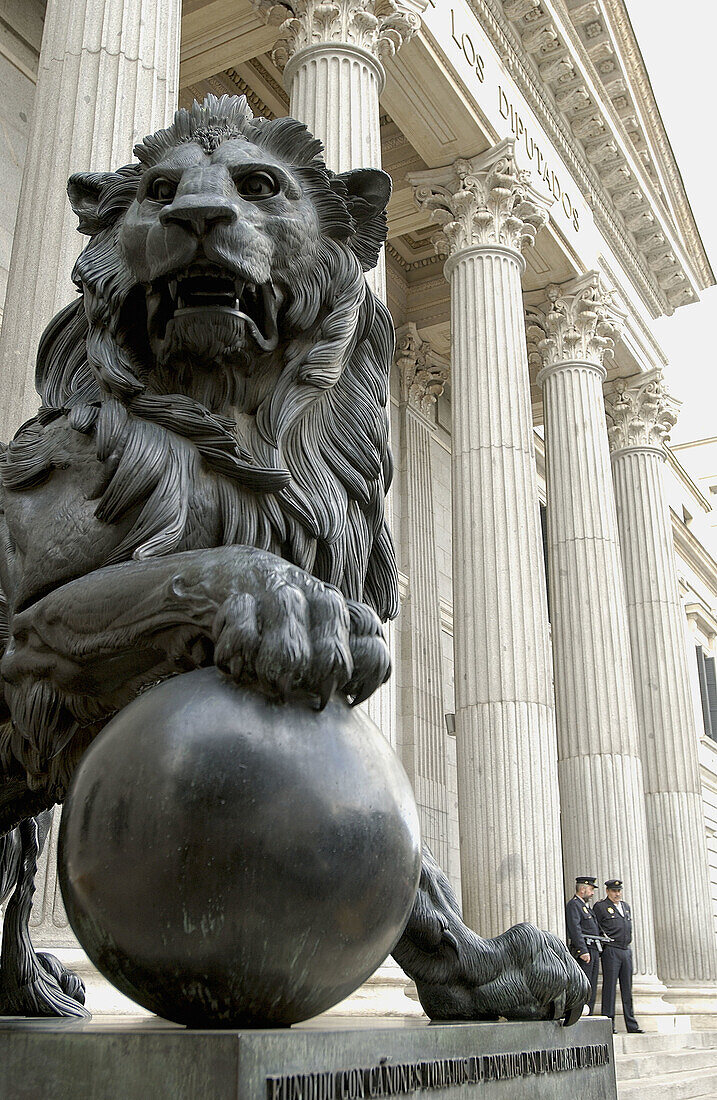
[[605, 370, 680, 451]]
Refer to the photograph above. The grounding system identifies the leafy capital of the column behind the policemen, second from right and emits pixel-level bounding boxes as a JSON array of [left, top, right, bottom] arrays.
[[526, 272, 626, 370]]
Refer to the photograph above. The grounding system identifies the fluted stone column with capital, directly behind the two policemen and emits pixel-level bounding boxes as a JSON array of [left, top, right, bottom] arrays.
[[528, 273, 661, 980]]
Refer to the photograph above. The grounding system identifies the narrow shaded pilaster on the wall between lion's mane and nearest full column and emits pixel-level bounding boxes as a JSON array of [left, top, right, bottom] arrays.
[[396, 325, 449, 870]]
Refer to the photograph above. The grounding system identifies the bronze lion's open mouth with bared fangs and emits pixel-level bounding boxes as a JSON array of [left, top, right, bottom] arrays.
[[147, 264, 282, 351]]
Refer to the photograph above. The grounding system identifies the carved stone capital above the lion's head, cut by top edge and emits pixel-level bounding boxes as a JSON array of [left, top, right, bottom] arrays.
[[251, 0, 428, 69]]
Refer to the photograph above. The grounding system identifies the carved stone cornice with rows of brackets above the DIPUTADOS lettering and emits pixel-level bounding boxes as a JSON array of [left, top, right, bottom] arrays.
[[450, 0, 715, 316]]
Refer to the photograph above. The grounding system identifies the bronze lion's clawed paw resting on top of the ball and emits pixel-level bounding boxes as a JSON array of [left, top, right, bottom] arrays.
[[212, 568, 373, 706]]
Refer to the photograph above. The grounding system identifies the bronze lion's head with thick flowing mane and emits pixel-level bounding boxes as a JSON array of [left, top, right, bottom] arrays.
[[8, 96, 397, 617]]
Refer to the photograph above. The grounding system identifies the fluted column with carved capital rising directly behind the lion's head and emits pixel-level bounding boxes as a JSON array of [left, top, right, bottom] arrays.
[[252, 0, 428, 300]]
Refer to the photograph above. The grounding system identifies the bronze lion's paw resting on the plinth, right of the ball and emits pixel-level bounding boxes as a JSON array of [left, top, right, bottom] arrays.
[[490, 924, 589, 1026]]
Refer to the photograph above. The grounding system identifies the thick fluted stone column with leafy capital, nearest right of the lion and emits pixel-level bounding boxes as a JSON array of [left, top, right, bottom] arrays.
[[410, 141, 563, 935]]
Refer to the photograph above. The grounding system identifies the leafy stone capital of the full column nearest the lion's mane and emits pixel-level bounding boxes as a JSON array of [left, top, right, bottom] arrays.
[[408, 139, 550, 256]]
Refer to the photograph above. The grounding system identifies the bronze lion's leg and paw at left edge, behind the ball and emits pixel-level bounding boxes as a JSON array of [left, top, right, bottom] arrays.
[[0, 811, 89, 1016]]
